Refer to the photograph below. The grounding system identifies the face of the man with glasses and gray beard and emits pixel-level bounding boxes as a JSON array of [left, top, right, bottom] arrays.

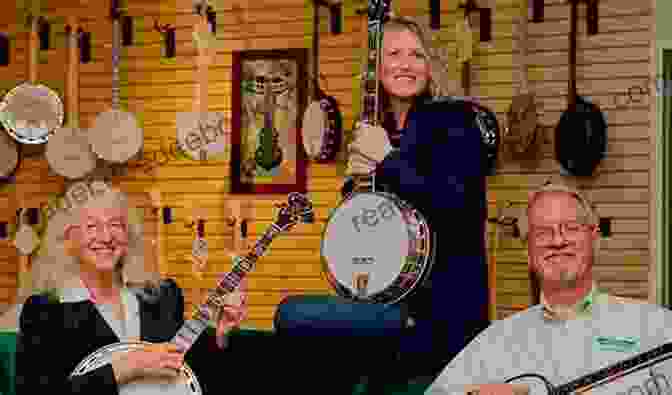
[[528, 192, 598, 288]]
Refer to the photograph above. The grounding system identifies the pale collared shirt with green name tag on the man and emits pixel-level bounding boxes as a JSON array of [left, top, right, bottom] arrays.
[[425, 287, 672, 395]]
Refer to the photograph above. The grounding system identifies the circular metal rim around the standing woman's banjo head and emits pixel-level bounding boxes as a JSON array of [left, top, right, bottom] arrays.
[[320, 191, 436, 305]]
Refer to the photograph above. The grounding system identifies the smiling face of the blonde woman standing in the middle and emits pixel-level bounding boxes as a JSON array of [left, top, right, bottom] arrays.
[[380, 26, 430, 98]]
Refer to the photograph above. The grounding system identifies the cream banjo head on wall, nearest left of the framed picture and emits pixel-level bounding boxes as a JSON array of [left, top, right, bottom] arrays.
[[175, 112, 229, 160]]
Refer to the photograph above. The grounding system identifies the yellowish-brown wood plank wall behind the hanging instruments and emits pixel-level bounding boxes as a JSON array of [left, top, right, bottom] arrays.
[[0, 0, 655, 329]]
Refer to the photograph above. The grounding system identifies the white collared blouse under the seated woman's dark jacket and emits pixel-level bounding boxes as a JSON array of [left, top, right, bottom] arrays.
[[60, 280, 140, 341]]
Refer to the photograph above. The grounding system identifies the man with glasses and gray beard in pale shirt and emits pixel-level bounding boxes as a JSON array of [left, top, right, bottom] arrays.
[[426, 184, 672, 395]]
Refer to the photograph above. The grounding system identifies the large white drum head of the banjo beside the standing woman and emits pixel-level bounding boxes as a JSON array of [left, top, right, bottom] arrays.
[[321, 192, 423, 303]]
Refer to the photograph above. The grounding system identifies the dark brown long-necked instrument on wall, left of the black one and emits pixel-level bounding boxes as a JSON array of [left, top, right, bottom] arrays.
[[503, 0, 543, 156]]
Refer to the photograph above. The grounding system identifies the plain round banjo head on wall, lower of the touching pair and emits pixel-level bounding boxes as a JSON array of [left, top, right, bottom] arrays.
[[45, 128, 96, 179]]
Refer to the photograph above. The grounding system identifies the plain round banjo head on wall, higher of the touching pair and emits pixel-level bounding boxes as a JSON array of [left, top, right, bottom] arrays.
[[88, 110, 143, 163]]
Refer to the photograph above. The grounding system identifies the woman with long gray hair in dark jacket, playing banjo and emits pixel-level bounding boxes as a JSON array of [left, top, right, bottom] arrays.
[[16, 183, 245, 395]]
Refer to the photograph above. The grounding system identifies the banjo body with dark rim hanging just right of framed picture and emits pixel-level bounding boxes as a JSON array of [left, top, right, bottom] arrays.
[[302, 76, 343, 163]]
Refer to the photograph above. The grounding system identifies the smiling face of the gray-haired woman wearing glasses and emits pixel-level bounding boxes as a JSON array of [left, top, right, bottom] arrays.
[[69, 207, 129, 272]]
